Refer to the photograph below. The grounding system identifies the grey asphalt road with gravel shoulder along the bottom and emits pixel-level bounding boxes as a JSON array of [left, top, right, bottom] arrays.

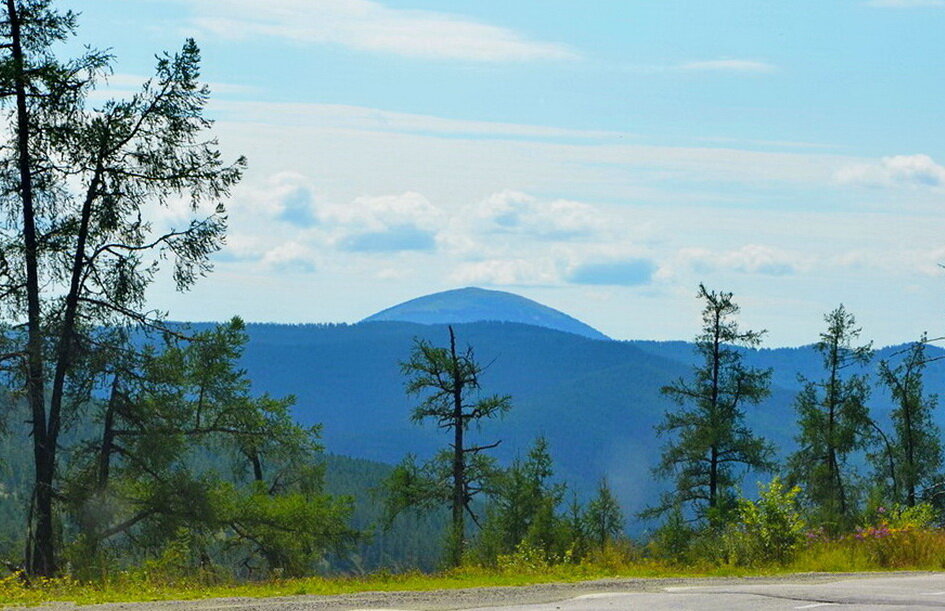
[[22, 573, 945, 611]]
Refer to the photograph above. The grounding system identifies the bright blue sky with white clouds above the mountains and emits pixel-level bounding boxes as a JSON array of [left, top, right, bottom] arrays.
[[57, 0, 945, 345]]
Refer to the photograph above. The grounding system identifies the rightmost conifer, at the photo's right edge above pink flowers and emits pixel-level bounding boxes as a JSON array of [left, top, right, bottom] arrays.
[[877, 336, 942, 507]]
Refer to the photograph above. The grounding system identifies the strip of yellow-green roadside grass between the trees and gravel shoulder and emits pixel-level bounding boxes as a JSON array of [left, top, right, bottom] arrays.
[[0, 529, 945, 606]]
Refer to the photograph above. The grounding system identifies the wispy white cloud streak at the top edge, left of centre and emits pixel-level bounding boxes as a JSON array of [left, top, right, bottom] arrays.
[[181, 0, 577, 62]]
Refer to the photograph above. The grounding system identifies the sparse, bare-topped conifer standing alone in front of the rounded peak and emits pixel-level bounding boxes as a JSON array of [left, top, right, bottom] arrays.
[[386, 326, 511, 566]]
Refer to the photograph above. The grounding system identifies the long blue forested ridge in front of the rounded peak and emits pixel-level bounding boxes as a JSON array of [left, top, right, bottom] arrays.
[[181, 322, 945, 524]]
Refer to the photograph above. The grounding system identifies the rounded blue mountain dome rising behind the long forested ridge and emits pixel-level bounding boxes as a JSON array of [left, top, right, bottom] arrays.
[[361, 287, 610, 340]]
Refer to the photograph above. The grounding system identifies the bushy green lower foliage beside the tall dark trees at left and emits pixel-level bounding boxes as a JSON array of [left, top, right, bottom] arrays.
[[63, 319, 355, 574]]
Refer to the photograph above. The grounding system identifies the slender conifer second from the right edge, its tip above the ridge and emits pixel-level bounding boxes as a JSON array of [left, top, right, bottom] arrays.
[[789, 305, 873, 529]]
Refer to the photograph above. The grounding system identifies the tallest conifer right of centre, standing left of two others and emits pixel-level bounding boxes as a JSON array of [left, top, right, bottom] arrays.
[[643, 284, 773, 522]]
